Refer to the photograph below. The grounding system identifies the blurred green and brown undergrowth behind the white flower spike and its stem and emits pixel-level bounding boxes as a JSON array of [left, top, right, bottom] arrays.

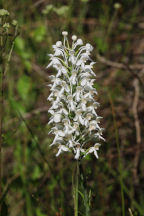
[[0, 0, 144, 216]]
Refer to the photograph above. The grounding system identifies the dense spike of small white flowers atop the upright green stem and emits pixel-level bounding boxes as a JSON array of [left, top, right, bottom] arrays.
[[47, 32, 104, 160]]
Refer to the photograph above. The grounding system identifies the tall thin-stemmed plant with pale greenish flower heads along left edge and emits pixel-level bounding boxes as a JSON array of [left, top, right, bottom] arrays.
[[0, 9, 18, 215]]
